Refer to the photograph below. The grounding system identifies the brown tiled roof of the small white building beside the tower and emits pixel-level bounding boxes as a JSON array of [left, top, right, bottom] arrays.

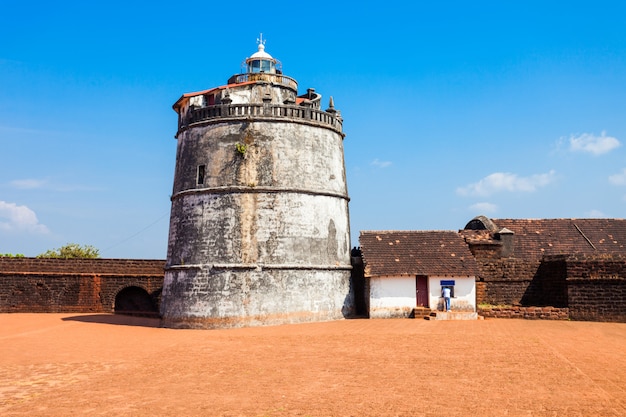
[[359, 231, 478, 277]]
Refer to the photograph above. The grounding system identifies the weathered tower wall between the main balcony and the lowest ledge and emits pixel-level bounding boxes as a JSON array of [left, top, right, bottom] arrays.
[[168, 118, 350, 265]]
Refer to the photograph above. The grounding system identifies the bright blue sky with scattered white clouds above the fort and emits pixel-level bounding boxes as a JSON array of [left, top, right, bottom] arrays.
[[0, 0, 626, 259]]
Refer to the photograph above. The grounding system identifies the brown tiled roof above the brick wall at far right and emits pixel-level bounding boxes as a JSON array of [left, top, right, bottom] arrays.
[[472, 219, 626, 259]]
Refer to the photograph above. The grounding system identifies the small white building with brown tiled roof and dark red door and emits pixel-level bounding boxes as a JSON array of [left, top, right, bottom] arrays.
[[359, 231, 478, 318]]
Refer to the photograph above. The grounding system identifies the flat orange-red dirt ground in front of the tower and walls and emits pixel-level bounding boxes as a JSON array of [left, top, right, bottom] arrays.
[[0, 314, 626, 417]]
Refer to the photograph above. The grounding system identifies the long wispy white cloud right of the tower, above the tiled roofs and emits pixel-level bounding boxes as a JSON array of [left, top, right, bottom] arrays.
[[456, 170, 556, 197]]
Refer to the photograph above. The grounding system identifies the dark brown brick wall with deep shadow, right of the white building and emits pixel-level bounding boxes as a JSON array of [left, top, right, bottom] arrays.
[[476, 250, 626, 322]]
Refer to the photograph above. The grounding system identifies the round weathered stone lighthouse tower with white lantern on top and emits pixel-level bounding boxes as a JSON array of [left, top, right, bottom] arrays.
[[161, 39, 354, 328]]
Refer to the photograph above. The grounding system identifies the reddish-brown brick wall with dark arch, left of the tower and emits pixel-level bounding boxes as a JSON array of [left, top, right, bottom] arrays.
[[0, 258, 165, 313]]
